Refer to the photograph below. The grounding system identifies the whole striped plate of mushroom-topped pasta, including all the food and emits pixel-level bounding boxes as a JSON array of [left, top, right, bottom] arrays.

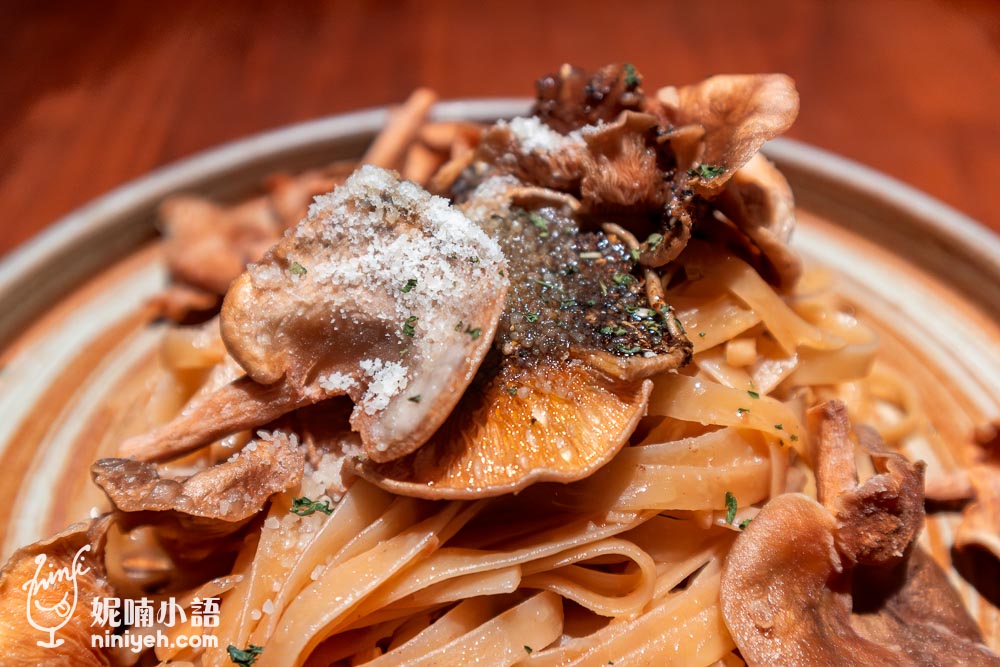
[[0, 64, 1000, 667]]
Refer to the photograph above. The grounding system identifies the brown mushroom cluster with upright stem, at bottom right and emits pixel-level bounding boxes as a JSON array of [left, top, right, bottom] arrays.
[[721, 403, 1000, 665]]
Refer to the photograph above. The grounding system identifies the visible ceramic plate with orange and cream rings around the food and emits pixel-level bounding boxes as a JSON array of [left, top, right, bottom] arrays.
[[0, 100, 1000, 650]]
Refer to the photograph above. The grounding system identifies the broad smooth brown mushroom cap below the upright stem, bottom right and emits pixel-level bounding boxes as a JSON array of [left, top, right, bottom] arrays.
[[721, 494, 1000, 666]]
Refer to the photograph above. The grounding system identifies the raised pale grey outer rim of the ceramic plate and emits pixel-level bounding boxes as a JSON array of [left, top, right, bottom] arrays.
[[0, 98, 1000, 348]]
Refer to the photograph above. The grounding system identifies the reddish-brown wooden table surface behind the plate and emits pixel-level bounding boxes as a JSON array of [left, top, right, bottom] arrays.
[[0, 0, 1000, 253]]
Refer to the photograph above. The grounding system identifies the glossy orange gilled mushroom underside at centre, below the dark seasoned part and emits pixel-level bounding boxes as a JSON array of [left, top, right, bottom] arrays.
[[350, 362, 652, 499]]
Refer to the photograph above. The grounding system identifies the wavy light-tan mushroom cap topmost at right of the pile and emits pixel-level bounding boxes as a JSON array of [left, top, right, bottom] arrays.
[[647, 74, 799, 196]]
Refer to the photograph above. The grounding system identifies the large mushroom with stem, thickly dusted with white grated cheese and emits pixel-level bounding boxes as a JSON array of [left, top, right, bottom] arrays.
[[122, 166, 509, 461]]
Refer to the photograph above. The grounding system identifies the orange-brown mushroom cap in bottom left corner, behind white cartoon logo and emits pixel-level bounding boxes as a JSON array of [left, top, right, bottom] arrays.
[[0, 516, 115, 667]]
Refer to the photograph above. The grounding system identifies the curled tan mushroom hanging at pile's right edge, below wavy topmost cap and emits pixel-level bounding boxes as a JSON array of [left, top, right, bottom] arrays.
[[718, 153, 802, 289]]
